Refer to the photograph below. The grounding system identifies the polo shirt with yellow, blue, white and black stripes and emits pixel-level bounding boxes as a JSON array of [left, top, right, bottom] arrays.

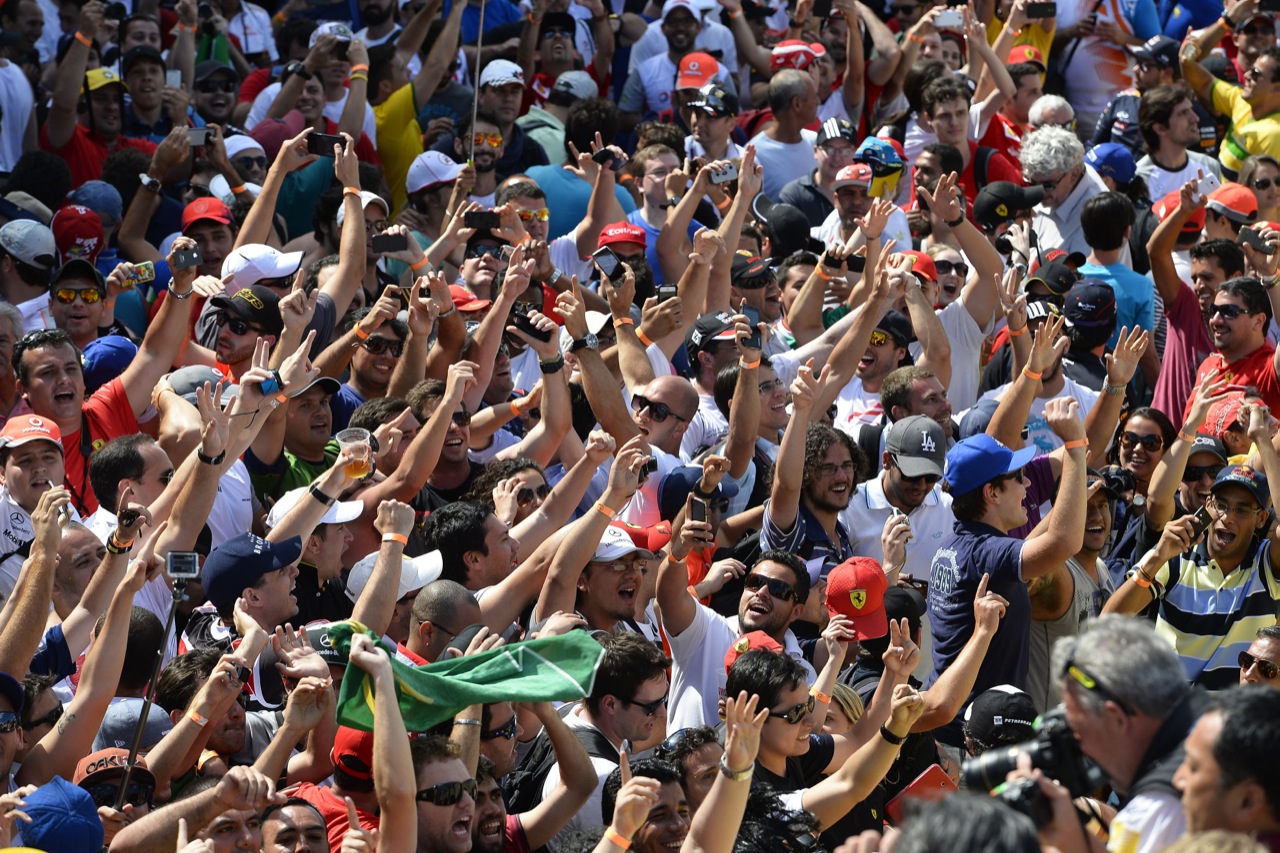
[[1151, 539, 1280, 690]]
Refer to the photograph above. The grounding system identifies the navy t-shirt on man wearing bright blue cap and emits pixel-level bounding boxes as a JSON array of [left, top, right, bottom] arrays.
[[929, 521, 1032, 745]]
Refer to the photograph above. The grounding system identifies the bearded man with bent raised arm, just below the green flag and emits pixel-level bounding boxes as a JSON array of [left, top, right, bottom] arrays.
[[471, 702, 595, 853]]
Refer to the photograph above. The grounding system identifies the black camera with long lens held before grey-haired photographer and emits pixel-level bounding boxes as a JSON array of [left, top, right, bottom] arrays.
[[961, 706, 1106, 827]]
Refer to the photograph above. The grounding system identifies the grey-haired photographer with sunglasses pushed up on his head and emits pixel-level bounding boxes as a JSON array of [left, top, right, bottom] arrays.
[[1037, 615, 1204, 853]]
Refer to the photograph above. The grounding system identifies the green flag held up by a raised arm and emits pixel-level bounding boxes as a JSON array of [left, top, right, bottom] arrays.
[[329, 620, 604, 731]]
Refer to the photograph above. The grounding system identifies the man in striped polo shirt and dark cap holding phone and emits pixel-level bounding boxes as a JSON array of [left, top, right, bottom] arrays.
[[1102, 403, 1280, 690]]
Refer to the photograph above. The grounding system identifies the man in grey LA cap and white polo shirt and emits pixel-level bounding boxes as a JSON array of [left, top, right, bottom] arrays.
[[840, 415, 955, 585]]
